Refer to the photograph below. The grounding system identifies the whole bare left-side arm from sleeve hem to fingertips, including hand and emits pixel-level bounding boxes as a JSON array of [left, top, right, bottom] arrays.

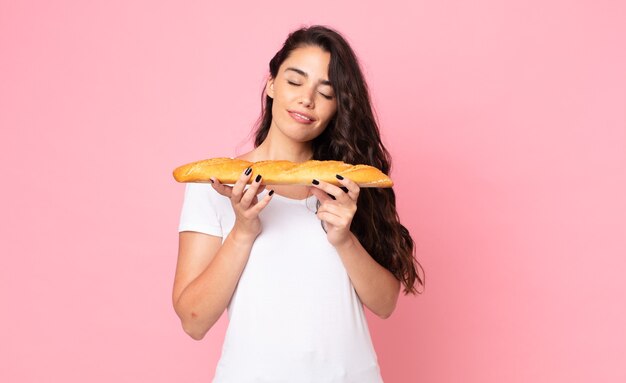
[[172, 167, 272, 340]]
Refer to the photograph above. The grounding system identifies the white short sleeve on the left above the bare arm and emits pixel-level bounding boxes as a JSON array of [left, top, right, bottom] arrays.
[[178, 182, 222, 237]]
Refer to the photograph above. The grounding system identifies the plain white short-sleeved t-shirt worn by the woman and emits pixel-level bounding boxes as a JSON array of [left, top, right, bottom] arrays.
[[179, 183, 383, 383]]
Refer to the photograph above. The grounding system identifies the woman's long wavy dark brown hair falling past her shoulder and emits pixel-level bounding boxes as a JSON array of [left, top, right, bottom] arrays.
[[253, 25, 425, 295]]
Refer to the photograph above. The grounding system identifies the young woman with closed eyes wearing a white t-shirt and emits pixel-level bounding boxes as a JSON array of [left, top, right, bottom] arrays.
[[173, 26, 424, 383]]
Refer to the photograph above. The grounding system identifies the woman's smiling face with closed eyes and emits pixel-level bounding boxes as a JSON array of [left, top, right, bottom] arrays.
[[265, 46, 337, 142]]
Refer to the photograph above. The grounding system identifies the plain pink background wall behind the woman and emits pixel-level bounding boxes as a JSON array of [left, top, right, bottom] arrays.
[[0, 0, 626, 383]]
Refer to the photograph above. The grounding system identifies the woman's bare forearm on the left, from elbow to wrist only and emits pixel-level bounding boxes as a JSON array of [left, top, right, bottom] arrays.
[[175, 230, 254, 340]]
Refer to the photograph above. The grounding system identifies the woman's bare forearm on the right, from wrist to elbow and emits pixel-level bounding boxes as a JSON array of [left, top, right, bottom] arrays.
[[336, 233, 400, 318]]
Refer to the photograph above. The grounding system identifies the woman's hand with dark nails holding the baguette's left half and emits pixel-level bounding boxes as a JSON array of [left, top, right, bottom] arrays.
[[211, 168, 272, 240]]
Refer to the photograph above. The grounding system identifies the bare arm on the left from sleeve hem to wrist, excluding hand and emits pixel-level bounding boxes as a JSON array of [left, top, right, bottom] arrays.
[[172, 229, 254, 340]]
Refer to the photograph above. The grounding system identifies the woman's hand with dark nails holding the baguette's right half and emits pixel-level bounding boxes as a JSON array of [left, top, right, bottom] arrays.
[[311, 176, 361, 247]]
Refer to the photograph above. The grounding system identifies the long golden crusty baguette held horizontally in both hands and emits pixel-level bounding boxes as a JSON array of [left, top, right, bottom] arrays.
[[174, 157, 393, 188]]
